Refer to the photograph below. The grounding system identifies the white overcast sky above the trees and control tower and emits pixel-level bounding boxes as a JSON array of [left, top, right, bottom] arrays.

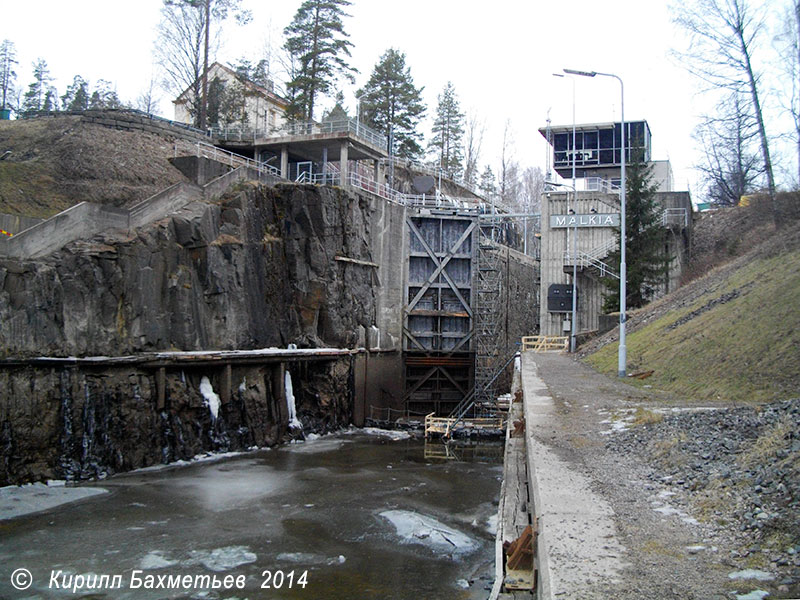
[[0, 0, 788, 201]]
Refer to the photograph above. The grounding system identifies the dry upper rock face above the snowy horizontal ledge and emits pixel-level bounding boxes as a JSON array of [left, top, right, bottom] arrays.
[[0, 185, 375, 356]]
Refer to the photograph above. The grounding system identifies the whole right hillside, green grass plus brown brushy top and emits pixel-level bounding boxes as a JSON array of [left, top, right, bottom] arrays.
[[581, 194, 800, 403]]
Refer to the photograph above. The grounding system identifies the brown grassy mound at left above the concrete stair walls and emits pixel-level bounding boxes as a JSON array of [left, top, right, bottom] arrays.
[[0, 115, 200, 218]]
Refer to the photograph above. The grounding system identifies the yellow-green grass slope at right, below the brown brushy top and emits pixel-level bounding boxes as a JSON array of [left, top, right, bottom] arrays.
[[587, 225, 800, 402]]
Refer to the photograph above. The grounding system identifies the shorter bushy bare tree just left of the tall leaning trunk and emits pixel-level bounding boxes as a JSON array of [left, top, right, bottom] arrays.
[[694, 92, 764, 206]]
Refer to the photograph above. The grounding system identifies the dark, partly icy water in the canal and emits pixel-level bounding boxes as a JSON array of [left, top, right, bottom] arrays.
[[0, 433, 502, 600]]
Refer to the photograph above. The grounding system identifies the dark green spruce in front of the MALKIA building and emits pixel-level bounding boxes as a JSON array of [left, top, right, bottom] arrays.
[[603, 150, 672, 312]]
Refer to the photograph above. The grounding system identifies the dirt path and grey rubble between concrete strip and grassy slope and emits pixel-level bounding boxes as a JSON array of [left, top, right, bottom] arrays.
[[536, 355, 800, 600]]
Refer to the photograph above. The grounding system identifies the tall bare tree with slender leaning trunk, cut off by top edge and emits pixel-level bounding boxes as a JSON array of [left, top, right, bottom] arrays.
[[674, 0, 778, 221]]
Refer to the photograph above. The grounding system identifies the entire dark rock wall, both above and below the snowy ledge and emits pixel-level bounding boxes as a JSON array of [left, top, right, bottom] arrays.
[[0, 184, 376, 485]]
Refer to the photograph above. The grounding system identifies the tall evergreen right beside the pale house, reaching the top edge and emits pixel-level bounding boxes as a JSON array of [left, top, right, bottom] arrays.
[[283, 0, 356, 121]]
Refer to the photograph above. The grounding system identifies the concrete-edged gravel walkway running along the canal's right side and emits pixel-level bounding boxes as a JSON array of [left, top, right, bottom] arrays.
[[522, 352, 730, 600]]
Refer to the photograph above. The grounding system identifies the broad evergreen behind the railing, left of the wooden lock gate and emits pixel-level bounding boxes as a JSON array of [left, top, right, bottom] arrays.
[[356, 48, 425, 158]]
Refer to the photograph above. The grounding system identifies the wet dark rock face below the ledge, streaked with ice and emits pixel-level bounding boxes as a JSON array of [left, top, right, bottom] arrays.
[[0, 358, 352, 486]]
